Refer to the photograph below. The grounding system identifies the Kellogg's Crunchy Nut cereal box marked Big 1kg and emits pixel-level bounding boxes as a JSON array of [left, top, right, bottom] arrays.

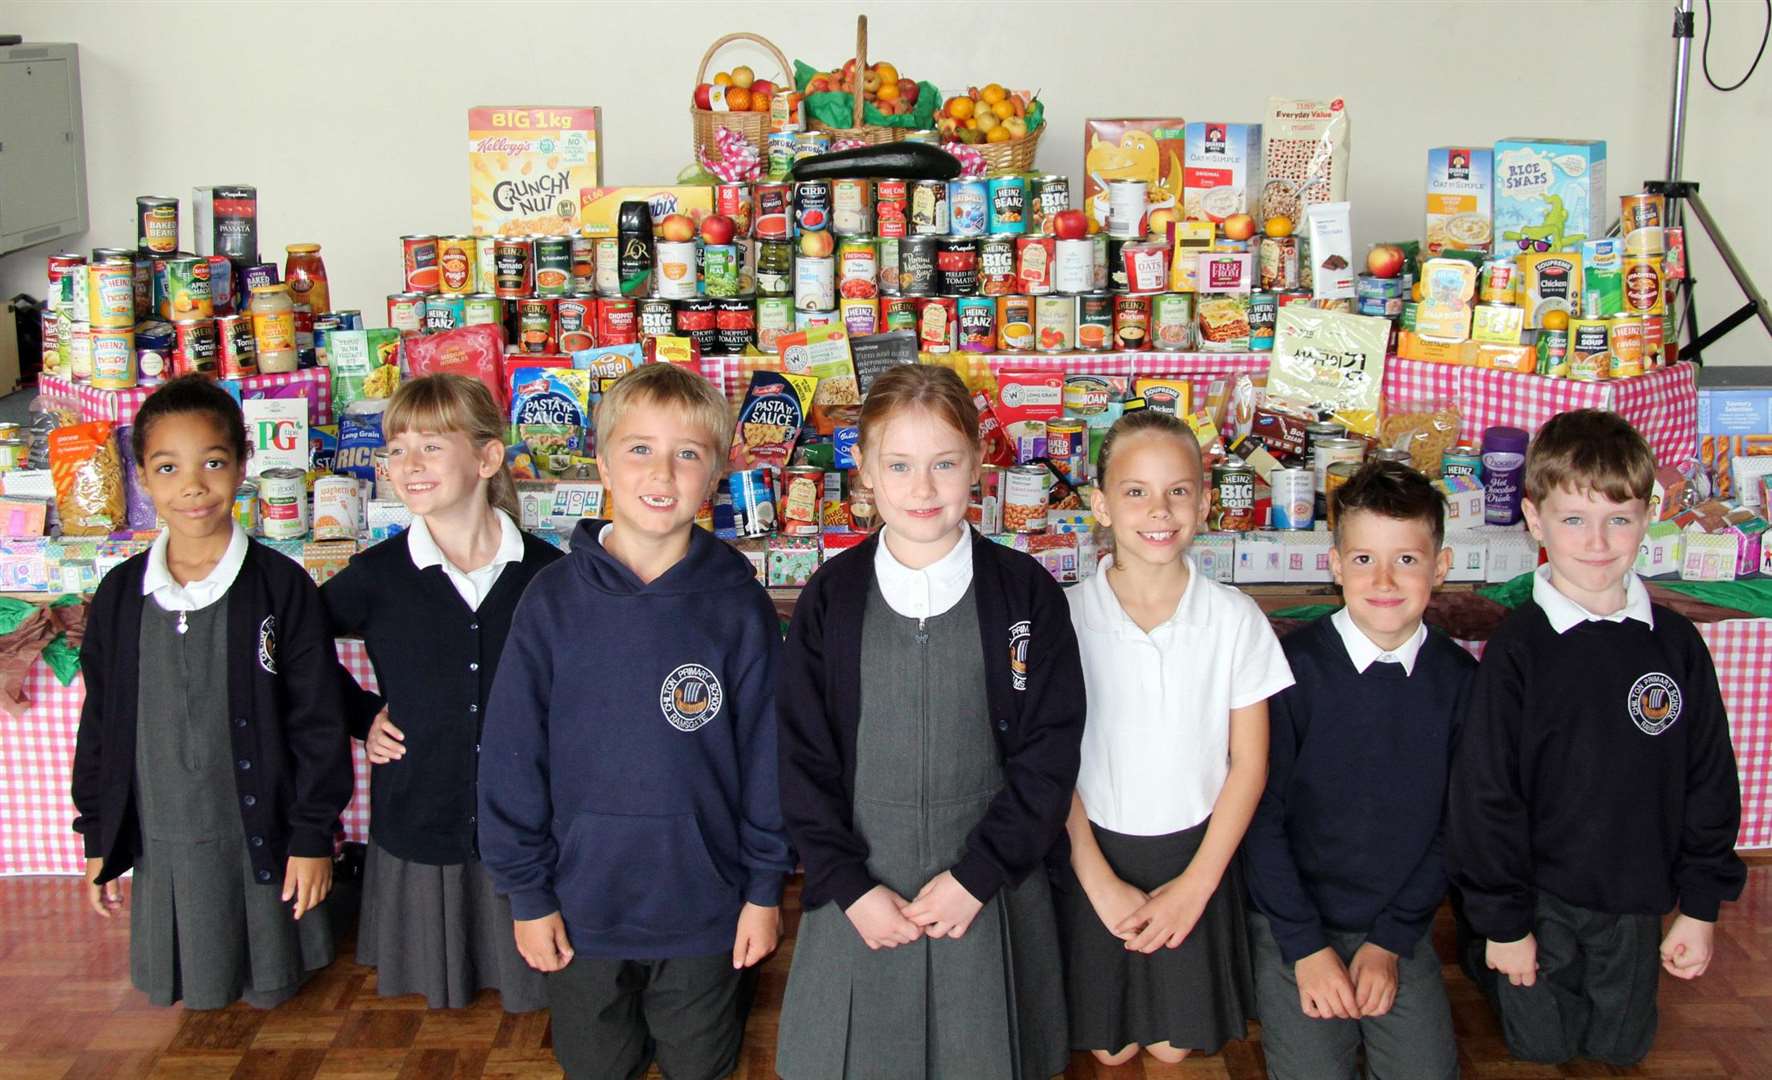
[[468, 105, 602, 236]]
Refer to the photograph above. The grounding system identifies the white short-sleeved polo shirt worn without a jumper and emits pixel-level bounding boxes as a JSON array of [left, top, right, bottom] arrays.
[[1067, 555, 1292, 837]]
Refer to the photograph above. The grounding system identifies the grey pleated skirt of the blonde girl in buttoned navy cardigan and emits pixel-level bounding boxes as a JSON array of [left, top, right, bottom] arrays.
[[356, 839, 548, 1013]]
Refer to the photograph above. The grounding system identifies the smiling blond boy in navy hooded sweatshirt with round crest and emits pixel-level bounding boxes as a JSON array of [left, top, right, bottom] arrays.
[[480, 364, 794, 1080]]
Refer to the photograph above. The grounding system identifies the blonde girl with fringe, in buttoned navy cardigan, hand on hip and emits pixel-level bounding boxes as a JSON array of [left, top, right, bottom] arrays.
[[321, 374, 560, 1013]]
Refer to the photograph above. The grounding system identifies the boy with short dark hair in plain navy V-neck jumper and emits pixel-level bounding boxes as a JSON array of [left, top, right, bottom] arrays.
[[1244, 463, 1476, 1080]]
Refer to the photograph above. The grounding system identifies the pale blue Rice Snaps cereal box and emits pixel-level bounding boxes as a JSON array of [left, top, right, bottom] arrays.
[[1494, 138, 1607, 255]]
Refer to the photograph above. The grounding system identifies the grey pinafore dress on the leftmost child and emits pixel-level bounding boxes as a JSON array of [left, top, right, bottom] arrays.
[[129, 596, 333, 1009]]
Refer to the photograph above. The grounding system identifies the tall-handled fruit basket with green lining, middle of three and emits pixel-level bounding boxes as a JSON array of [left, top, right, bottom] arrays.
[[794, 16, 941, 144]]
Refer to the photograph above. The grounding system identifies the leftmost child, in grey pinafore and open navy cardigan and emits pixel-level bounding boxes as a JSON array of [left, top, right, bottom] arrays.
[[73, 376, 351, 1009]]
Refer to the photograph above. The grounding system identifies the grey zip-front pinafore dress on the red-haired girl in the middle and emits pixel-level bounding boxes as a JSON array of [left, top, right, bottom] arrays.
[[776, 583, 1069, 1080]]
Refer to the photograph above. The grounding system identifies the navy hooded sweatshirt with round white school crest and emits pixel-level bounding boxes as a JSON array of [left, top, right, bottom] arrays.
[[480, 521, 794, 959]]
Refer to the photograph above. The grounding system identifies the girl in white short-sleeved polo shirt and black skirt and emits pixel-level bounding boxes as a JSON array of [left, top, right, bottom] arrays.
[[1056, 410, 1292, 1064]]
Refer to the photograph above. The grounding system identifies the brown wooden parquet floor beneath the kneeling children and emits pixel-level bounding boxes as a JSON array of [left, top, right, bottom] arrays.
[[0, 864, 1772, 1080]]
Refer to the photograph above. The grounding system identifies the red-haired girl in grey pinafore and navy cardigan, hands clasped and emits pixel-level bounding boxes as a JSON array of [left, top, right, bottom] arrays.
[[776, 364, 1083, 1080]]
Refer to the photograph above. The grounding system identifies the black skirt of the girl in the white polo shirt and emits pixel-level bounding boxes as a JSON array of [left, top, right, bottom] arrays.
[[1053, 819, 1255, 1053]]
